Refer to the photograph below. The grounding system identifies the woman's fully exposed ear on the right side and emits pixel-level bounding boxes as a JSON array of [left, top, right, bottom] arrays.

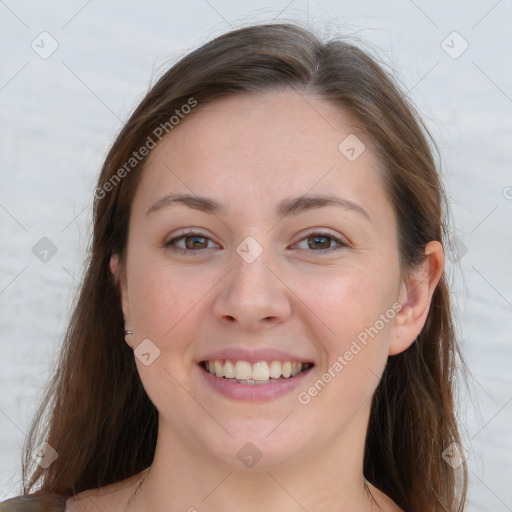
[[389, 241, 444, 356]]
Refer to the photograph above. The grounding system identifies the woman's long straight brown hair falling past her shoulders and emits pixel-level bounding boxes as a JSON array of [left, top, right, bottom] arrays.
[[18, 24, 467, 511]]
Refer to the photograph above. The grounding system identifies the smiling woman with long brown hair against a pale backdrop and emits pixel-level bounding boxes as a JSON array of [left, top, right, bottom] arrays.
[[2, 24, 466, 512]]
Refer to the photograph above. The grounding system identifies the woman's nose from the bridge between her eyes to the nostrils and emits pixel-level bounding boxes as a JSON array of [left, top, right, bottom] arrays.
[[215, 237, 290, 328]]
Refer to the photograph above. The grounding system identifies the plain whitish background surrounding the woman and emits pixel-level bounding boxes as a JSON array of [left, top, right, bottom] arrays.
[[0, 0, 512, 512]]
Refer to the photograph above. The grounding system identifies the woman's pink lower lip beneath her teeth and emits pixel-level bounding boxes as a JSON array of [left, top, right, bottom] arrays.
[[198, 366, 312, 400]]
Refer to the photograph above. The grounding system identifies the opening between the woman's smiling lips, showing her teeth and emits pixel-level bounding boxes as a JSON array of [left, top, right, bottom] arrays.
[[199, 359, 314, 385]]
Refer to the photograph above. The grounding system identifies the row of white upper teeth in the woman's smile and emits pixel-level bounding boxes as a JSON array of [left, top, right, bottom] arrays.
[[206, 360, 302, 380]]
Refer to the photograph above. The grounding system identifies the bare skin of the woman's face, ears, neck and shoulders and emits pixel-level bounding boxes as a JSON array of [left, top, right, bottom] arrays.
[[67, 91, 444, 512]]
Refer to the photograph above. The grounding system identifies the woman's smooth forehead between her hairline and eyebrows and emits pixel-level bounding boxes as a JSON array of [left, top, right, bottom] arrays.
[[130, 90, 389, 224]]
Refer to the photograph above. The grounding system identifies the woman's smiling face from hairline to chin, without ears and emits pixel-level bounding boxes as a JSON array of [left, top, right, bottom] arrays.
[[112, 91, 412, 467]]
